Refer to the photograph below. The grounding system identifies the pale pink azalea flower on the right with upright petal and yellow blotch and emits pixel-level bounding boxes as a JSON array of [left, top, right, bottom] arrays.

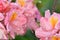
[[35, 10, 60, 40]]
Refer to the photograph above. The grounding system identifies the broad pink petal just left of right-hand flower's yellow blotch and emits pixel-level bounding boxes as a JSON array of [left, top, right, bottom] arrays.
[[40, 17, 52, 31]]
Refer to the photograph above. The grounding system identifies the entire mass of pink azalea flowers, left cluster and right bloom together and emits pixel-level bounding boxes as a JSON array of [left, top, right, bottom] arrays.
[[0, 0, 60, 40]]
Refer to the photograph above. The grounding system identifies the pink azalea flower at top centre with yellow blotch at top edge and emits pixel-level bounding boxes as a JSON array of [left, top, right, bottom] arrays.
[[16, 0, 40, 30]]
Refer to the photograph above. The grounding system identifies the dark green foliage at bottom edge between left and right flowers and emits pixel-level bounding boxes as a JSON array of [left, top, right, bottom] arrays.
[[14, 30, 38, 40]]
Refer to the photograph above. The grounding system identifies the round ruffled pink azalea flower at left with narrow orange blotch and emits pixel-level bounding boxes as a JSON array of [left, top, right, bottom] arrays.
[[5, 5, 27, 38]]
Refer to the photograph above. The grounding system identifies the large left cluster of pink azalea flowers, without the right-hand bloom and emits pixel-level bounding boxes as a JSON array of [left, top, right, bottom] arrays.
[[0, 0, 40, 39]]
